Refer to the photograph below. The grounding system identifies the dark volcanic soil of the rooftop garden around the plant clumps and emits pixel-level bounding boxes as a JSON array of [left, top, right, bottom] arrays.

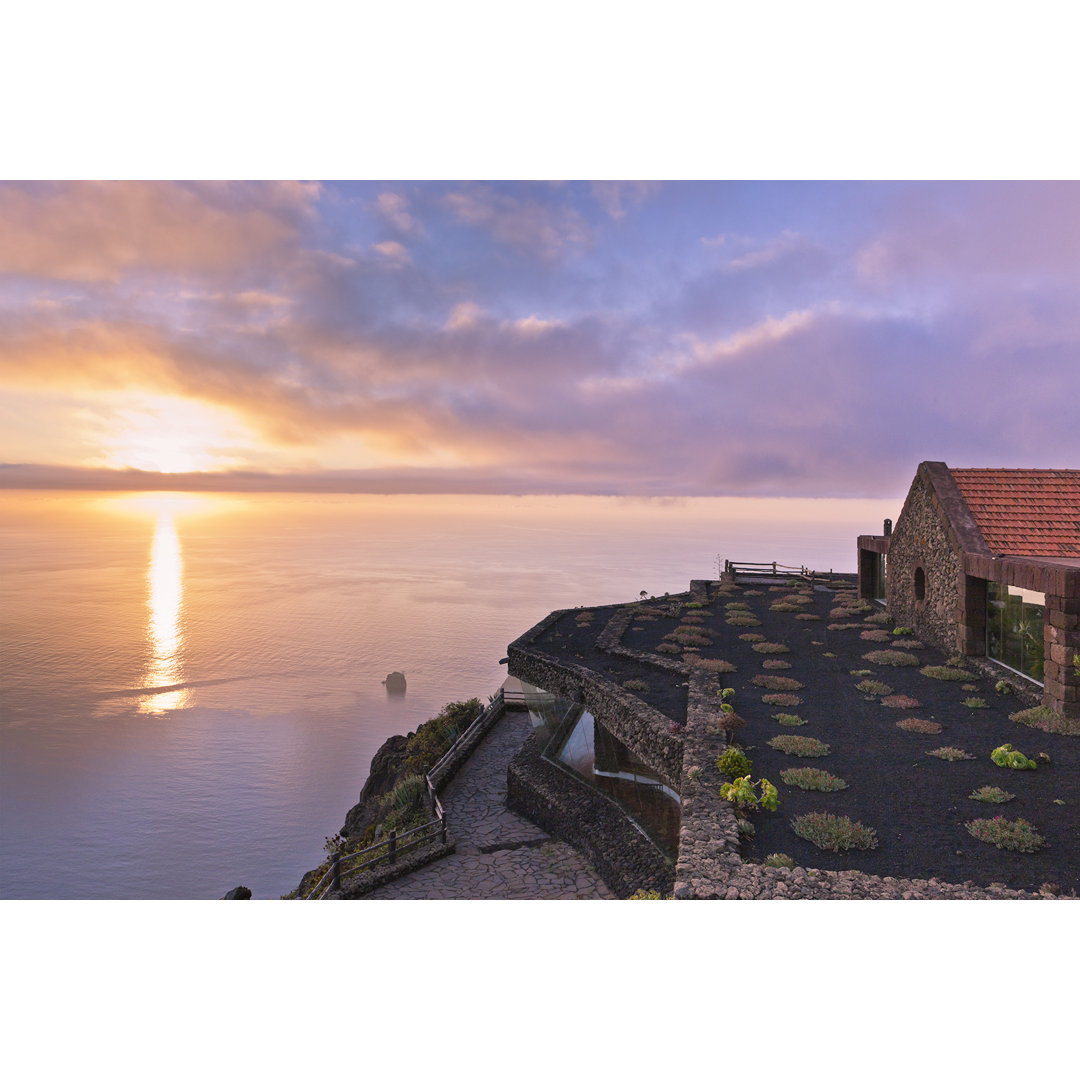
[[527, 584, 1080, 894]]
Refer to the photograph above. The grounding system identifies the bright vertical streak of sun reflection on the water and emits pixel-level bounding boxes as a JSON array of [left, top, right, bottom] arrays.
[[139, 509, 189, 715]]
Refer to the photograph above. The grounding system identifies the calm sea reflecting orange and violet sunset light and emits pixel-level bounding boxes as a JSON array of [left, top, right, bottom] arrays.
[[0, 492, 899, 899]]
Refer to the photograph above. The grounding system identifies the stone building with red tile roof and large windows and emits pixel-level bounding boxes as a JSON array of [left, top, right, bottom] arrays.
[[859, 461, 1080, 716]]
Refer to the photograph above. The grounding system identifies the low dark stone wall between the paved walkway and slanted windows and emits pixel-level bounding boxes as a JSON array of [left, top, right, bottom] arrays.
[[507, 734, 675, 900]]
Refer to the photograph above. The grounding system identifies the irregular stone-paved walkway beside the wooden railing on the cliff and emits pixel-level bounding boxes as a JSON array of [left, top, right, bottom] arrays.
[[363, 711, 616, 900]]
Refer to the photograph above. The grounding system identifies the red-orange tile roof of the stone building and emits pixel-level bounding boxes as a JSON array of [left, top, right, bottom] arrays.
[[949, 469, 1080, 558]]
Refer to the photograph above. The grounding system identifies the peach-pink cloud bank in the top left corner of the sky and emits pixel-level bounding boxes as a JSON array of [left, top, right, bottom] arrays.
[[0, 180, 320, 282]]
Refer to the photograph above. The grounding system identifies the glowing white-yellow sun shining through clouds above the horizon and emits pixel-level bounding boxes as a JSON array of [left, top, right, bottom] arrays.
[[102, 395, 249, 473]]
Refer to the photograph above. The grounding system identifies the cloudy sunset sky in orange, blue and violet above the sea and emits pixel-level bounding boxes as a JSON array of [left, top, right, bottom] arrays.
[[0, 180, 1080, 497]]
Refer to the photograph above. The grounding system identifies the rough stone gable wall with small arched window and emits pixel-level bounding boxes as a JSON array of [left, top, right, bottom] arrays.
[[887, 472, 962, 654]]
